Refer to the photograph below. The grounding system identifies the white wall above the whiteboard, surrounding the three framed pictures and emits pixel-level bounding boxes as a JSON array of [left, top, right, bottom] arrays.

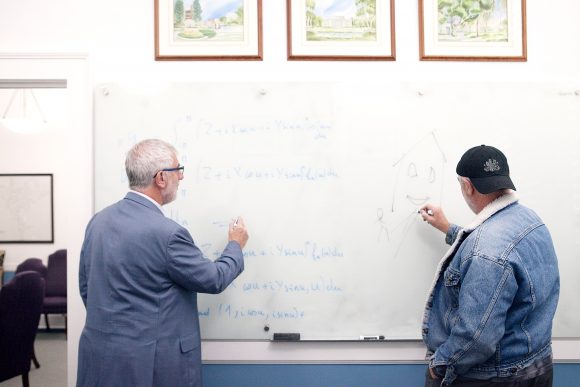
[[0, 0, 580, 82]]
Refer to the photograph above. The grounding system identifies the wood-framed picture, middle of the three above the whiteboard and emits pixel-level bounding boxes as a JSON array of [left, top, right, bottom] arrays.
[[286, 0, 395, 60]]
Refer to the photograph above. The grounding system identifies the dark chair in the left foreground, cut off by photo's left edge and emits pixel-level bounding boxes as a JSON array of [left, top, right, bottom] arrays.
[[0, 271, 44, 387]]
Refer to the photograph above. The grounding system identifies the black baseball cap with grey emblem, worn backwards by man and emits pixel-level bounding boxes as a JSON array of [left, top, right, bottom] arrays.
[[455, 145, 516, 194]]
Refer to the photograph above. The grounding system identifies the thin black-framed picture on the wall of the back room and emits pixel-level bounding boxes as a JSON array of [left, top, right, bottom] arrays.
[[0, 174, 54, 243]]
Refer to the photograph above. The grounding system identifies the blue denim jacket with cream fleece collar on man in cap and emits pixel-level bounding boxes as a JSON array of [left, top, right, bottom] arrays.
[[422, 193, 560, 385]]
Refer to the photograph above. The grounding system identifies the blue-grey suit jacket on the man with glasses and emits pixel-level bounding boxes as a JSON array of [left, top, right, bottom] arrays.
[[77, 192, 244, 387]]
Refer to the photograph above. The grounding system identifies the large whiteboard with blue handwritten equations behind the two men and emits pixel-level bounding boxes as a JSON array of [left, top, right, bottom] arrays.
[[95, 82, 580, 340]]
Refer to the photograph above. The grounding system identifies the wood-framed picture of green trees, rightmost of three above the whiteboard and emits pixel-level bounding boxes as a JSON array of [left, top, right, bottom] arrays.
[[419, 0, 527, 62]]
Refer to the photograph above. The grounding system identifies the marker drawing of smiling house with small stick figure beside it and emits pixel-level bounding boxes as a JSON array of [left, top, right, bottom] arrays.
[[377, 132, 447, 256]]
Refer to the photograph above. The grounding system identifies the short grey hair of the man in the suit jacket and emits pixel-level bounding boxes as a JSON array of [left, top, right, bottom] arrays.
[[125, 139, 177, 189]]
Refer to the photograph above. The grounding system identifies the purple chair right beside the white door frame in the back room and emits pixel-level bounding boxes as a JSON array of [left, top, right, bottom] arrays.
[[42, 249, 67, 332]]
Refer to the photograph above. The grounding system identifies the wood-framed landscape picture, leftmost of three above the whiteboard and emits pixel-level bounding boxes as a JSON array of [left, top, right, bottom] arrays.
[[155, 0, 262, 60]]
